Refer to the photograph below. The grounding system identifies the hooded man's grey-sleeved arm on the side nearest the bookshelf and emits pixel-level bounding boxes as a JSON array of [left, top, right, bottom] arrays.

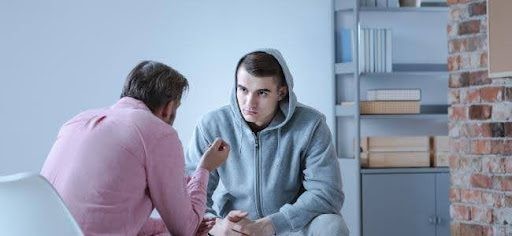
[[269, 117, 345, 234]]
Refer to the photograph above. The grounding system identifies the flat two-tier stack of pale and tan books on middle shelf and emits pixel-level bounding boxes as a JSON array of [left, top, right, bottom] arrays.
[[360, 89, 421, 114]]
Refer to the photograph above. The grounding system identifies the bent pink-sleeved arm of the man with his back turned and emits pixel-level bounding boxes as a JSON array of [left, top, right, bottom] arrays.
[[145, 131, 208, 235]]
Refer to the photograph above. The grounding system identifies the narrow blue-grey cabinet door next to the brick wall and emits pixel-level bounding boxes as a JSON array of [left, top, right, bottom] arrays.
[[436, 173, 450, 236]]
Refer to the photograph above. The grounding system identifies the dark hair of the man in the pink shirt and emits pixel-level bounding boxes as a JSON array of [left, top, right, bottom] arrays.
[[121, 61, 188, 112]]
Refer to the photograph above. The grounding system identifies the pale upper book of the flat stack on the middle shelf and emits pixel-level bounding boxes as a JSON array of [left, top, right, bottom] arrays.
[[366, 89, 421, 101]]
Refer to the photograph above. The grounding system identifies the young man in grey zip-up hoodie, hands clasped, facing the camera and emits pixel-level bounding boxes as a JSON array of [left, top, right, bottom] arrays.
[[186, 49, 348, 235]]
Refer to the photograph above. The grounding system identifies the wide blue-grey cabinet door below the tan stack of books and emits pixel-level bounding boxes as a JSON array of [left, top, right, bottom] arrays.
[[362, 173, 436, 236]]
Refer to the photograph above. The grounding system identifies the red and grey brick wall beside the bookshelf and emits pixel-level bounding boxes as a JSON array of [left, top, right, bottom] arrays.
[[447, 0, 512, 236]]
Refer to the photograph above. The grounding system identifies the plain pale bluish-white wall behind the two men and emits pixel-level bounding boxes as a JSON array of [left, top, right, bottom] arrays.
[[0, 0, 334, 175]]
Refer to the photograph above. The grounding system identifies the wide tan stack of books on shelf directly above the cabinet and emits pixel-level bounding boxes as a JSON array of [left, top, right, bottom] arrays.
[[360, 136, 430, 168]]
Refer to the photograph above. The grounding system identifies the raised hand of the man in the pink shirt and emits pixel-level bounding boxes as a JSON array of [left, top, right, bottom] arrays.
[[198, 138, 229, 172]]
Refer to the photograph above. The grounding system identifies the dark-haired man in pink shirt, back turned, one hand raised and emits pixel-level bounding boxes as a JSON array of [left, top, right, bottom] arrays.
[[41, 61, 229, 235]]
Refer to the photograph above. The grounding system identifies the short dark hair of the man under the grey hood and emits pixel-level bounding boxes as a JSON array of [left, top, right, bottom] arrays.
[[235, 51, 287, 86]]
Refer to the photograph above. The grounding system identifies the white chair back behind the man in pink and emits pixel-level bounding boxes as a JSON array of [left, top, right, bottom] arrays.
[[0, 173, 83, 236]]
